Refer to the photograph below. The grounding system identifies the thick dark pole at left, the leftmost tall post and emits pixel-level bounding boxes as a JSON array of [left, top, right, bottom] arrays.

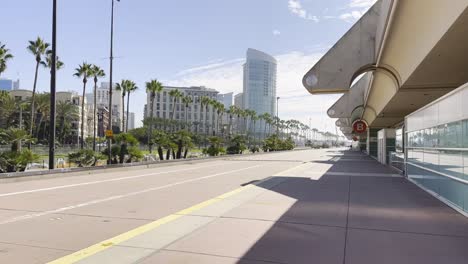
[[49, 0, 57, 170]]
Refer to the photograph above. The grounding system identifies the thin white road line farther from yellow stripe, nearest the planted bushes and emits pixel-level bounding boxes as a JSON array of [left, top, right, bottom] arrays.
[[0, 162, 229, 197]]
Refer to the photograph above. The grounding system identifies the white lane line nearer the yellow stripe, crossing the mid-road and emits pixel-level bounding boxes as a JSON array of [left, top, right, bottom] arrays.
[[0, 165, 264, 225]]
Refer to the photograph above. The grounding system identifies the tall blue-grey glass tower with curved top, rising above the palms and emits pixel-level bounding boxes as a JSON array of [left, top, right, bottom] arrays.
[[243, 49, 277, 133]]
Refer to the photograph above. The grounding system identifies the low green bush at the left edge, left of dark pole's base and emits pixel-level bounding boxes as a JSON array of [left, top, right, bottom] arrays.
[[0, 149, 39, 173]]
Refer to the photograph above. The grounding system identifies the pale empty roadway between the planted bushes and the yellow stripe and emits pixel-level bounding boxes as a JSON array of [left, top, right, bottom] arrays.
[[0, 150, 324, 263]]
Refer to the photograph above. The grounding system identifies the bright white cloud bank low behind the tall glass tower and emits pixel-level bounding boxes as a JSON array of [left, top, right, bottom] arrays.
[[163, 49, 340, 132]]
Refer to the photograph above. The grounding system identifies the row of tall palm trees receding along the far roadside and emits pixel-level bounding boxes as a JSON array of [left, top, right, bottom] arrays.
[[0, 37, 342, 151]]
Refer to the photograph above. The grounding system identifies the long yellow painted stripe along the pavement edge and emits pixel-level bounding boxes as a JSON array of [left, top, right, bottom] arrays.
[[48, 183, 256, 264]]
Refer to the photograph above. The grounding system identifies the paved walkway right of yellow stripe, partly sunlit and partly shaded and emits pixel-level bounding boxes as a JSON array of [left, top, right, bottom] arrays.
[[65, 150, 468, 264]]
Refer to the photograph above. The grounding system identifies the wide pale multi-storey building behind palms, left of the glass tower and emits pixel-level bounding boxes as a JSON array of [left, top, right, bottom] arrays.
[[144, 86, 219, 133]]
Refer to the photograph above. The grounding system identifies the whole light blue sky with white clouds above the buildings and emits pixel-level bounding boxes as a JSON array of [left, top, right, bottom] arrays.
[[0, 0, 375, 131]]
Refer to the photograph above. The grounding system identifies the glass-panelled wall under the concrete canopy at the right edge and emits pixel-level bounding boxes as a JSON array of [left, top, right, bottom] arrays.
[[406, 85, 468, 216]]
